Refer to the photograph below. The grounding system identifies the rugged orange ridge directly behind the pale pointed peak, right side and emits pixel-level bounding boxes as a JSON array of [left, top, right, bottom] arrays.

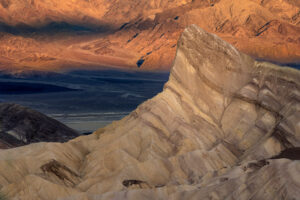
[[95, 0, 300, 69]]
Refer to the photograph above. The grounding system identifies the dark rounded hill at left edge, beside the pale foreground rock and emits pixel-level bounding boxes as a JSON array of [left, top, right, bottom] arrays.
[[0, 103, 79, 149]]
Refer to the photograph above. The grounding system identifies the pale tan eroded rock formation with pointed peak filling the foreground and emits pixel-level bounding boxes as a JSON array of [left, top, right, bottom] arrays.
[[0, 25, 300, 200]]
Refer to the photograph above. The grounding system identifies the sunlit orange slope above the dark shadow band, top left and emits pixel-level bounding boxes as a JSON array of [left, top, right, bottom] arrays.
[[0, 0, 191, 28]]
